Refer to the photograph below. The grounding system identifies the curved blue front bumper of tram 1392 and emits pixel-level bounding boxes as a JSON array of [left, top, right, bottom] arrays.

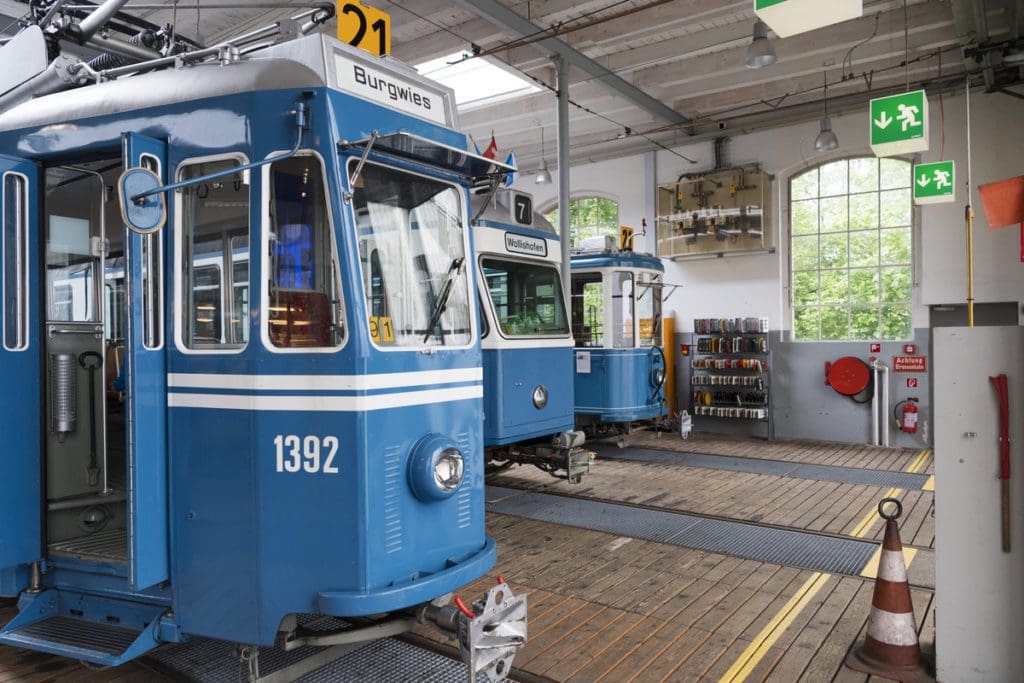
[[316, 537, 498, 617]]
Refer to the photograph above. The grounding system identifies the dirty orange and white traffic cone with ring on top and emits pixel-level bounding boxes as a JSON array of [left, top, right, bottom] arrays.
[[846, 498, 935, 683]]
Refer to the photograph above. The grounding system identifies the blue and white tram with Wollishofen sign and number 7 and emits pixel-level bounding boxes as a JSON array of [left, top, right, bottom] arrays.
[[473, 189, 593, 483]]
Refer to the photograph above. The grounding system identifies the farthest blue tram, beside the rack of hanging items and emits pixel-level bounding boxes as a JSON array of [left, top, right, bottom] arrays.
[[571, 250, 667, 436]]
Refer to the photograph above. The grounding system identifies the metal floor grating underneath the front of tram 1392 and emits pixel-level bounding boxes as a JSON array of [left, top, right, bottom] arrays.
[[148, 614, 469, 683]]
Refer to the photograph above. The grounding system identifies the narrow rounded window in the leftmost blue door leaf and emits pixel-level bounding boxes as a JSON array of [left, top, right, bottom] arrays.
[[3, 173, 29, 351]]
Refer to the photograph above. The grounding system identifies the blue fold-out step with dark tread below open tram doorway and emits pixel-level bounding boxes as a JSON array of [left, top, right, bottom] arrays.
[[0, 590, 166, 667]]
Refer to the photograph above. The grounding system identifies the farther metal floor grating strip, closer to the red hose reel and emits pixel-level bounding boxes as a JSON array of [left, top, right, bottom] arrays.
[[594, 444, 928, 490]]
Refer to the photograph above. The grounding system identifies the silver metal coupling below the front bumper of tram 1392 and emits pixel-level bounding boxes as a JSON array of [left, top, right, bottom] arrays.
[[418, 577, 526, 683]]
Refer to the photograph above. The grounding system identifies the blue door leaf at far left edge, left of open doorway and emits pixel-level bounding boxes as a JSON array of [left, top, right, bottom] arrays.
[[0, 156, 42, 589]]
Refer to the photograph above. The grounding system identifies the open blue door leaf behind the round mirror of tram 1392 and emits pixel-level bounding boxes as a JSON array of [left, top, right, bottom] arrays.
[[123, 133, 170, 590]]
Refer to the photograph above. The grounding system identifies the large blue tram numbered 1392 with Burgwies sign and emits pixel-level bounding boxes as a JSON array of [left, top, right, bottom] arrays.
[[0, 1, 525, 678]]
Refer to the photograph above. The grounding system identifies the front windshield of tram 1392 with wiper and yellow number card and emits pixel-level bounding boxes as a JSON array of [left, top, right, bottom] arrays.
[[352, 164, 472, 346]]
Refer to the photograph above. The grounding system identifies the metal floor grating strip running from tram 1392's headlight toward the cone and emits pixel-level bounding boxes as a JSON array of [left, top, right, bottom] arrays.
[[487, 486, 879, 577]]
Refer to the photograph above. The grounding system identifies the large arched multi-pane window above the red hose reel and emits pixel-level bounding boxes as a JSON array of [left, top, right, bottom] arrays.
[[790, 157, 913, 341]]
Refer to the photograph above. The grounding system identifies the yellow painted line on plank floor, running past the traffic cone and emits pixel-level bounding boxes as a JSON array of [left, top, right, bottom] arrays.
[[719, 449, 935, 683]]
